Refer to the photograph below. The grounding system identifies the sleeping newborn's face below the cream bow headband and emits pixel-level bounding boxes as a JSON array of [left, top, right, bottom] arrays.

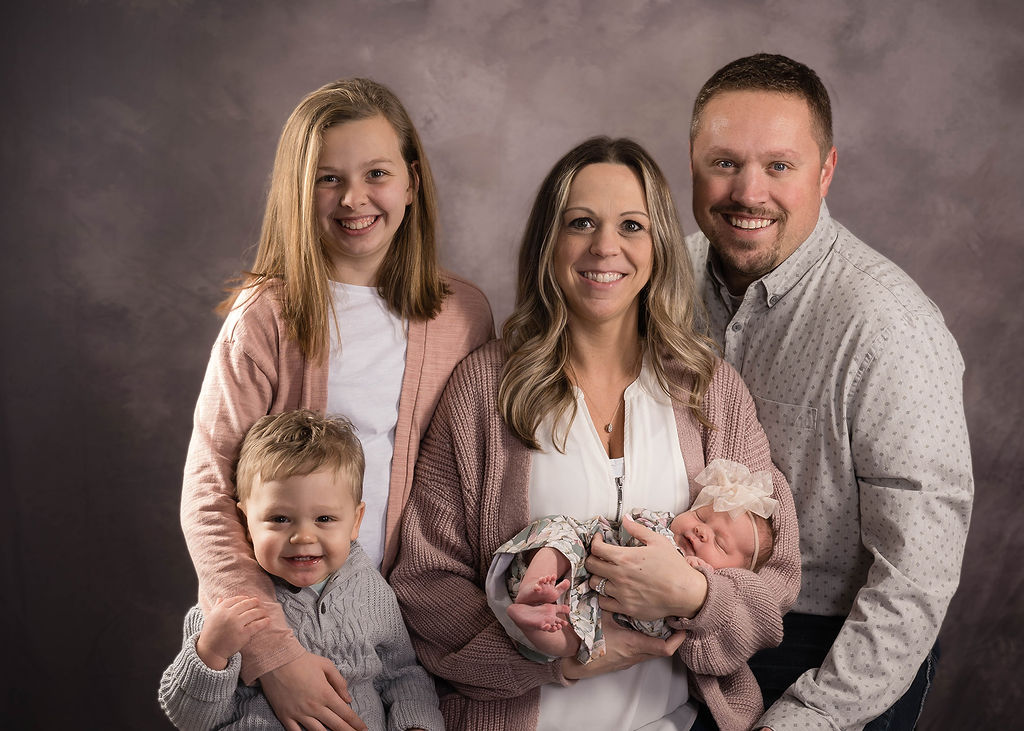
[[669, 505, 754, 568]]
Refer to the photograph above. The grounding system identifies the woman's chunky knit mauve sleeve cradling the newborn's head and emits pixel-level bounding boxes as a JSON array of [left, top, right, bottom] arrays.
[[680, 361, 800, 676]]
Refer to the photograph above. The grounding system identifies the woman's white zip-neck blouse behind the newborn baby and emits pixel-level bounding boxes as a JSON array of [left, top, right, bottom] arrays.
[[486, 360, 696, 731]]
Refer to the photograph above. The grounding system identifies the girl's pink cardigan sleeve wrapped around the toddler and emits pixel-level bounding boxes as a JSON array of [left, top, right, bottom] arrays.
[[181, 292, 304, 683]]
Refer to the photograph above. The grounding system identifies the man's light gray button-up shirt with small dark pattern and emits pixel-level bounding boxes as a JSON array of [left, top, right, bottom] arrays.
[[687, 197, 974, 731]]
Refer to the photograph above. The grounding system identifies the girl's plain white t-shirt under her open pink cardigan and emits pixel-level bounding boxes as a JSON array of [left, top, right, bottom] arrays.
[[327, 282, 409, 566]]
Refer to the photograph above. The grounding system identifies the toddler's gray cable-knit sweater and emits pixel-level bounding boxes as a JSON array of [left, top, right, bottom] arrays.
[[159, 543, 444, 731]]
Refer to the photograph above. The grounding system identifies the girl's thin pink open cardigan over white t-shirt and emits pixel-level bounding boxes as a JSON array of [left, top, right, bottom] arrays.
[[181, 274, 494, 683]]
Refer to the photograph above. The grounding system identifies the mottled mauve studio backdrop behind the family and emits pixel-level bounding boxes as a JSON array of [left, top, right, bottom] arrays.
[[0, 0, 1024, 729]]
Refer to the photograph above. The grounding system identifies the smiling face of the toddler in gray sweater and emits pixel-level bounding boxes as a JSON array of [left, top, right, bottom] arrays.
[[240, 469, 366, 587]]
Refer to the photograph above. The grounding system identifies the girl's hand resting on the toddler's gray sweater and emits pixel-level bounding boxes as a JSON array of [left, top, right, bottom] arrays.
[[259, 652, 367, 731]]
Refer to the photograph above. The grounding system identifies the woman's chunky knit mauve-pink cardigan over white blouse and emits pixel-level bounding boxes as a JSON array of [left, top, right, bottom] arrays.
[[390, 341, 800, 731]]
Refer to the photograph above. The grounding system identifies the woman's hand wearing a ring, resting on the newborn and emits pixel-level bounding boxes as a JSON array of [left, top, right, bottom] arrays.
[[585, 517, 708, 620]]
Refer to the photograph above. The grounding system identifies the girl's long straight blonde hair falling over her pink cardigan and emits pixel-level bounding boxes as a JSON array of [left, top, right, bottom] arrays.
[[218, 79, 449, 360]]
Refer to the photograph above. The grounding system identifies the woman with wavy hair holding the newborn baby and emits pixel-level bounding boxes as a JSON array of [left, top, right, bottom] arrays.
[[391, 137, 800, 729]]
